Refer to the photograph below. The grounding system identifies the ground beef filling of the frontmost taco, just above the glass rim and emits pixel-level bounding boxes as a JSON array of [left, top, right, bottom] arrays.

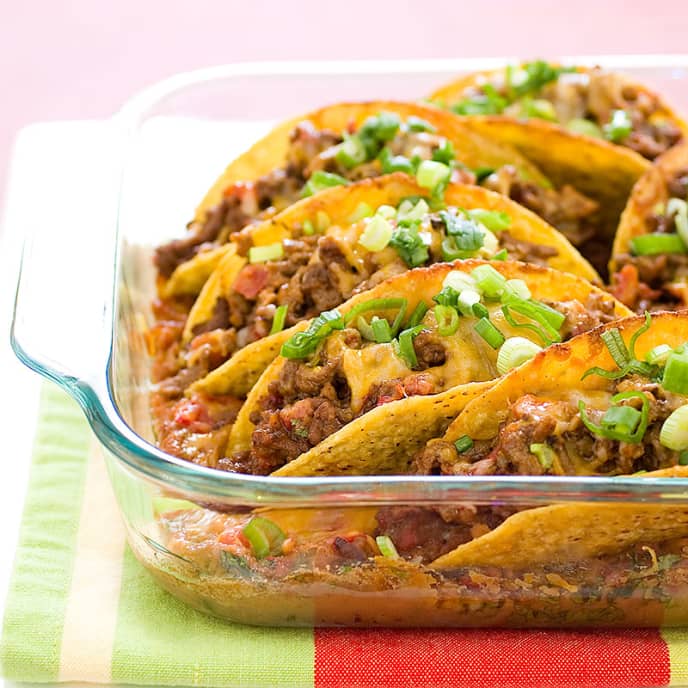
[[413, 376, 682, 475]]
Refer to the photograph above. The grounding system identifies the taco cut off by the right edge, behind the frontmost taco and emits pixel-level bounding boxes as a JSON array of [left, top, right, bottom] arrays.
[[609, 142, 688, 313]]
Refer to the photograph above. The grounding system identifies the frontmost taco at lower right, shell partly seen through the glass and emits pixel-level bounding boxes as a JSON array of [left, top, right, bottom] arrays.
[[392, 313, 688, 568]]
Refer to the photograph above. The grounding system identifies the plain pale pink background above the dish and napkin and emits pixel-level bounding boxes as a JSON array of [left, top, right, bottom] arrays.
[[0, 0, 688, 199]]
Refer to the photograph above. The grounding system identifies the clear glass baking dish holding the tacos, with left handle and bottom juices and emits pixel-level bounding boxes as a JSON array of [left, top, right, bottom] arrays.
[[10, 55, 688, 627]]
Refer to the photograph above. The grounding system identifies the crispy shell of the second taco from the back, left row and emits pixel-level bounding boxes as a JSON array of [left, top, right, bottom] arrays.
[[184, 173, 599, 396]]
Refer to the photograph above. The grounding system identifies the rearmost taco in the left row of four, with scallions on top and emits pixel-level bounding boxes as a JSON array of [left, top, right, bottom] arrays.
[[155, 102, 599, 298]]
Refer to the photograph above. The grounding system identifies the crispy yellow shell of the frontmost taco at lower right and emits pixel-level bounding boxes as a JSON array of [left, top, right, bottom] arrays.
[[433, 313, 688, 569]]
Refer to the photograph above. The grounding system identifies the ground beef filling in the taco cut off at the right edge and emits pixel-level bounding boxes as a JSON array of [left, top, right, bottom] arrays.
[[610, 170, 688, 313]]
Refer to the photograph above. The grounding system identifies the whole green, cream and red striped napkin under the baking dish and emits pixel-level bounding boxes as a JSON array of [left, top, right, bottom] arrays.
[[0, 384, 688, 688]]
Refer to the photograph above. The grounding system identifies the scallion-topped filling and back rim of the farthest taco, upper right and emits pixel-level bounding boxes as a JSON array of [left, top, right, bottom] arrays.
[[430, 60, 688, 160]]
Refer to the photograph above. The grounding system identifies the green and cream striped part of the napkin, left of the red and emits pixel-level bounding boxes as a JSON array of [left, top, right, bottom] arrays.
[[0, 384, 314, 687]]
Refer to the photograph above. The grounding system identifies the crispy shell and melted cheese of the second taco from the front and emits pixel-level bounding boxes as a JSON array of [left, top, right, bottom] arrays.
[[227, 260, 629, 476]]
